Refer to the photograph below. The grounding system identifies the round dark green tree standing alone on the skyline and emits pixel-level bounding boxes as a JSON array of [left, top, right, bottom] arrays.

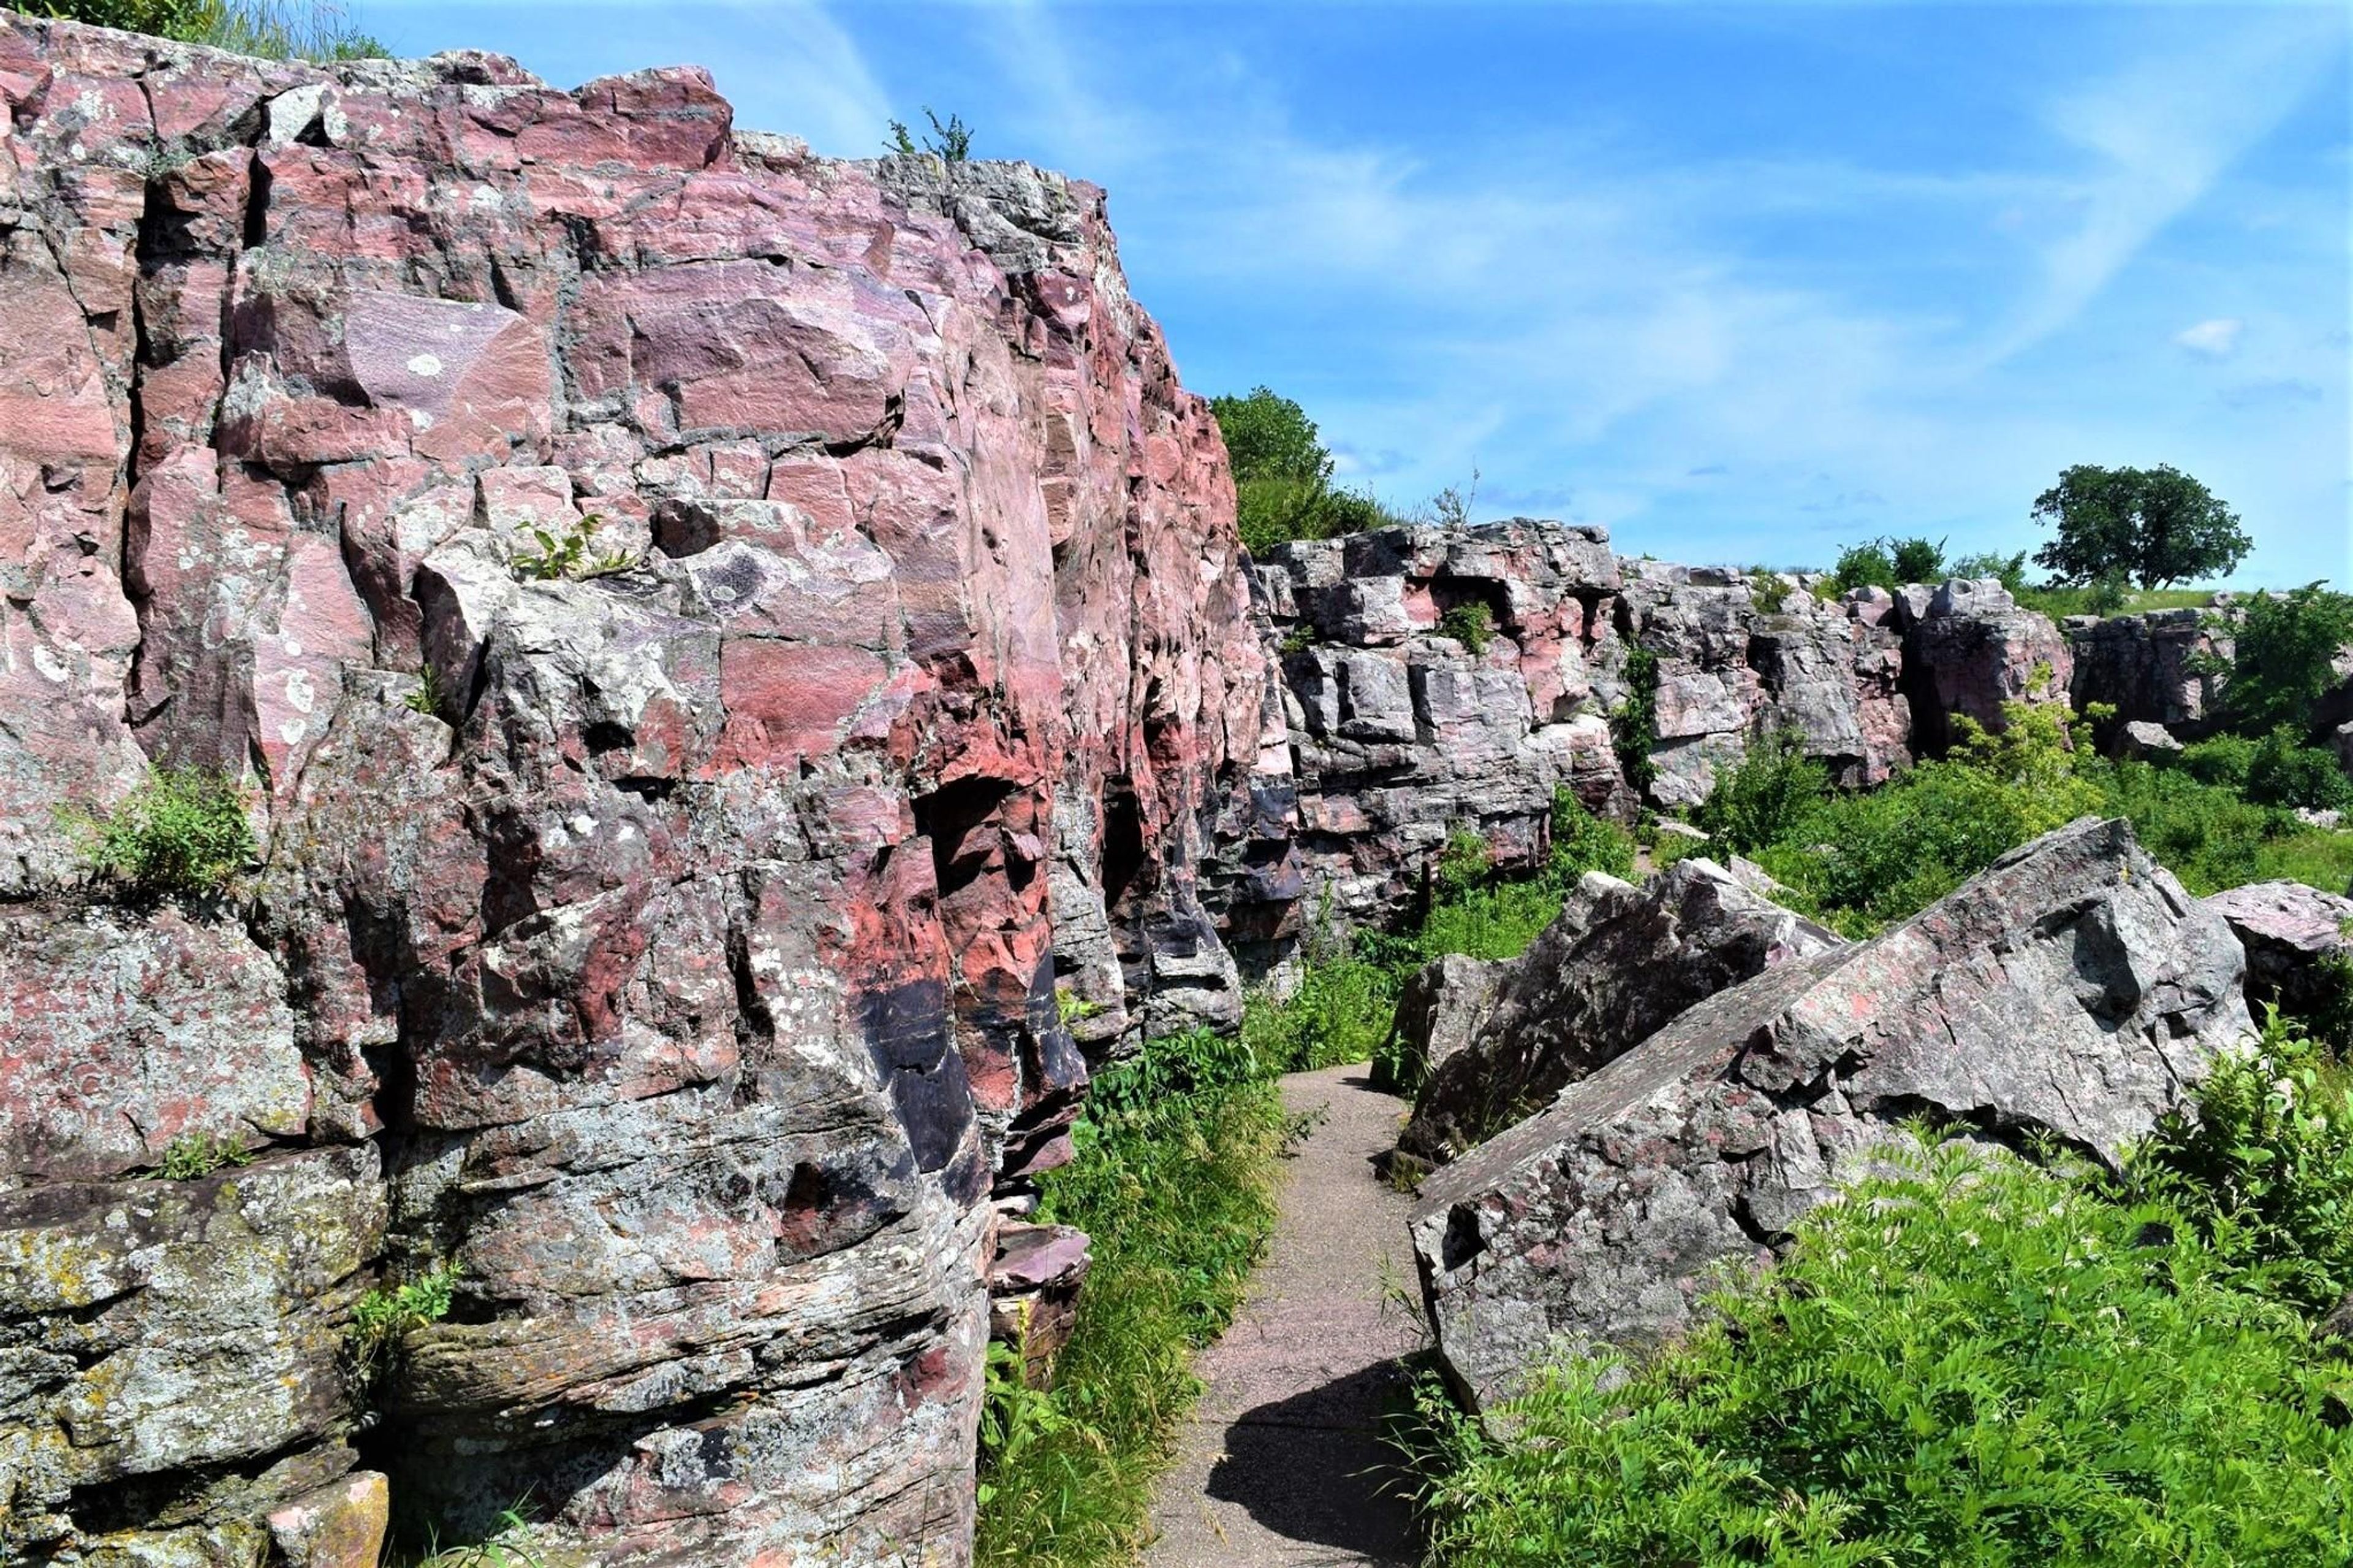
[[2033, 464, 2254, 589]]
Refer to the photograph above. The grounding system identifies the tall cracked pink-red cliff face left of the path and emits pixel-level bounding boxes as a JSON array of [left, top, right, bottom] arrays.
[[0, 14, 1302, 1563]]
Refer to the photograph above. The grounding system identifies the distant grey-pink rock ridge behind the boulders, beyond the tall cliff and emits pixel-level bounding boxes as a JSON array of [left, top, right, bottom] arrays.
[[1259, 518, 2071, 920]]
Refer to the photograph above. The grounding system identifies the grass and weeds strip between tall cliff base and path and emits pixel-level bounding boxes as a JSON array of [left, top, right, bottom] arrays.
[[977, 1040, 1297, 1568]]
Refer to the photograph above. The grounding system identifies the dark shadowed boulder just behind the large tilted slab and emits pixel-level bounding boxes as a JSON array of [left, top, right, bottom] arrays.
[[1398, 857, 1840, 1163]]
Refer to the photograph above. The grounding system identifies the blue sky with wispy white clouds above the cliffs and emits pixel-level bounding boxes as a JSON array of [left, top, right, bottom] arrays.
[[376, 0, 2353, 584]]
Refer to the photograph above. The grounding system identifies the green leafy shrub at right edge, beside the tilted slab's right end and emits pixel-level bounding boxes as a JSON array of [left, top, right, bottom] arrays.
[[2129, 1008, 2353, 1314]]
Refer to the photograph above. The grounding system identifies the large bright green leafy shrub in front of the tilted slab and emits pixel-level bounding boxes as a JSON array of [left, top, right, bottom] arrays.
[[1423, 1144, 2353, 1568]]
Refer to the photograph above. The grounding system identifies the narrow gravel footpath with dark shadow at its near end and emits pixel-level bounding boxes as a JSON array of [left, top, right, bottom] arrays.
[[1143, 1064, 1421, 1568]]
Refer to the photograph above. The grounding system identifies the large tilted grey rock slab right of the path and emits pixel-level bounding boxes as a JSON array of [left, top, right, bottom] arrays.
[[1412, 819, 2249, 1406]]
